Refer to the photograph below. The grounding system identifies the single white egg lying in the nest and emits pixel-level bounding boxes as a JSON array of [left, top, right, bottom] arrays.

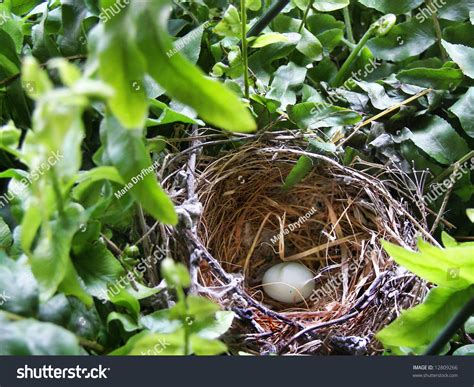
[[262, 262, 315, 304]]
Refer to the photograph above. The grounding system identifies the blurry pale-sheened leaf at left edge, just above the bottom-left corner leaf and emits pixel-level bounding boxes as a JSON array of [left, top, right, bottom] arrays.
[[0, 252, 39, 316]]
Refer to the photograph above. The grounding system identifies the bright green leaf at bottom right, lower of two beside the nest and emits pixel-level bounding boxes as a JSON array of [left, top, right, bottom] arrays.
[[376, 287, 474, 348]]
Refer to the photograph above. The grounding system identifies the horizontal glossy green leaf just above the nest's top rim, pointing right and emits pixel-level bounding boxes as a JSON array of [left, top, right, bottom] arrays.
[[288, 102, 362, 129]]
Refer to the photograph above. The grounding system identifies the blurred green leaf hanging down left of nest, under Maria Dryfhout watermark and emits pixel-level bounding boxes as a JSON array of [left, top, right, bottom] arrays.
[[101, 115, 178, 224]]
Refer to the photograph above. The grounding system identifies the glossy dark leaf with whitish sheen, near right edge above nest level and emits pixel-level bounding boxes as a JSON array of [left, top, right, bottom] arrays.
[[411, 116, 469, 165]]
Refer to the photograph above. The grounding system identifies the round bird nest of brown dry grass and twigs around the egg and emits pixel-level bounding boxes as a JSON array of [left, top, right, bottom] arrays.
[[165, 138, 429, 354]]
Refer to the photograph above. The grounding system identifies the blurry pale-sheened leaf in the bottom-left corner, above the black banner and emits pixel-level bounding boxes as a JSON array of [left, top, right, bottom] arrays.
[[0, 312, 83, 356]]
